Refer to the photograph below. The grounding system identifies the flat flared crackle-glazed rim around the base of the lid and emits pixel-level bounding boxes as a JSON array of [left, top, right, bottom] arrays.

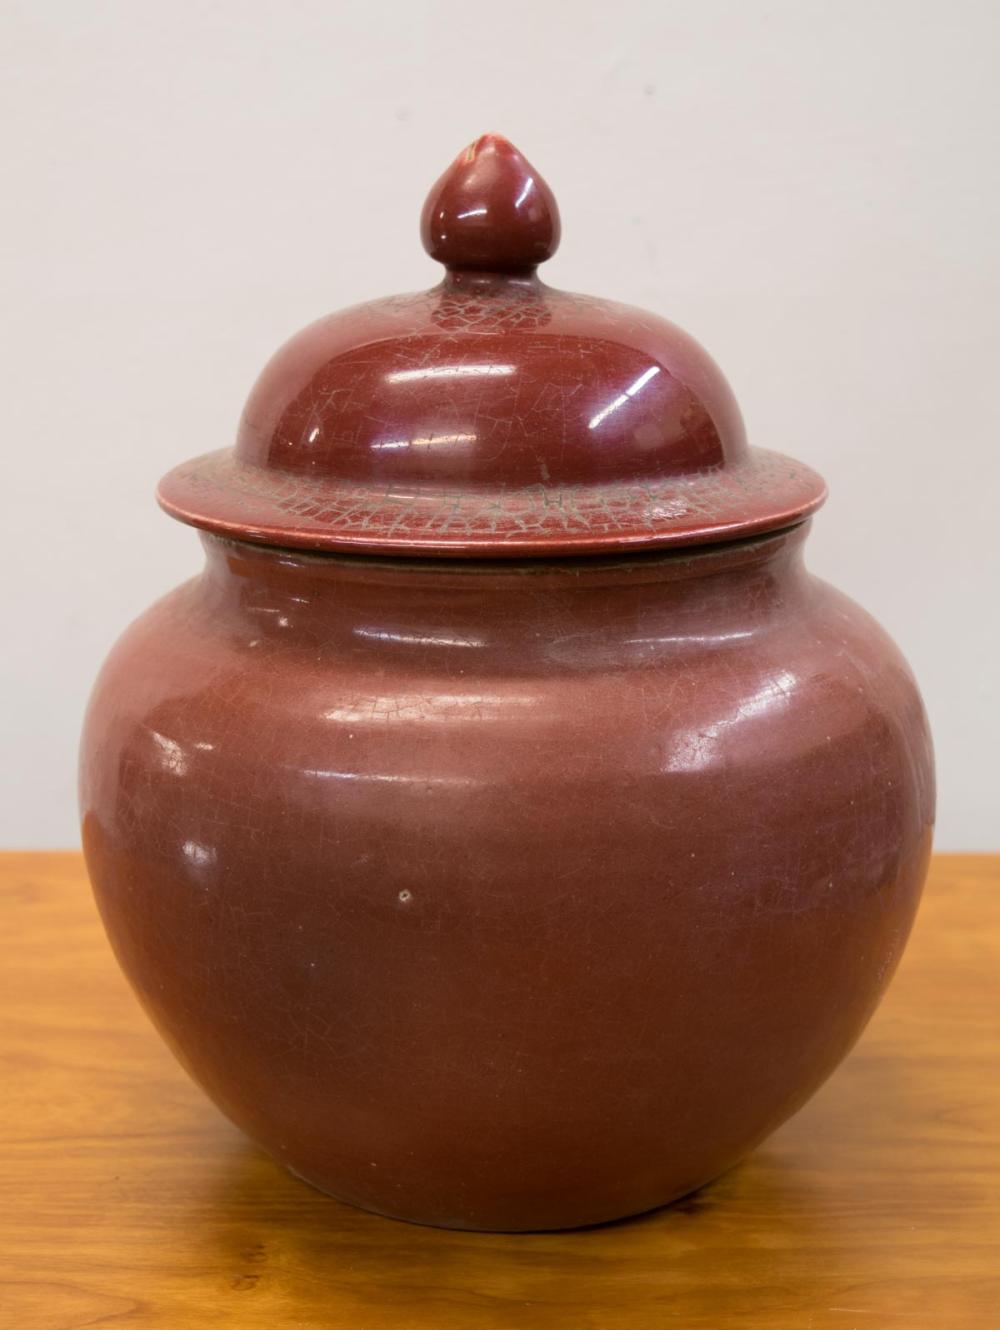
[[157, 448, 827, 559]]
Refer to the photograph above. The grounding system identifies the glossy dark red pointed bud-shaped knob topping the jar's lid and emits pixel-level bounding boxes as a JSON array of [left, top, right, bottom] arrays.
[[420, 134, 560, 273]]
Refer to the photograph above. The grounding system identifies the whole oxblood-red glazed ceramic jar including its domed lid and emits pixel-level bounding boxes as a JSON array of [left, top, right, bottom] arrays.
[[81, 136, 934, 1230]]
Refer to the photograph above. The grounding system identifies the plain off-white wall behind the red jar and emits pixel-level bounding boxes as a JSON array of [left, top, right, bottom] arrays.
[[0, 0, 1000, 849]]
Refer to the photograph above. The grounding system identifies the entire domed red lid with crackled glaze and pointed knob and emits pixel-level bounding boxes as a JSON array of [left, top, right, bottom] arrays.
[[160, 134, 824, 557]]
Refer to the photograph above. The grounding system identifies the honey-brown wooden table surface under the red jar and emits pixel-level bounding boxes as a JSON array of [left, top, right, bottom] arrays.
[[0, 854, 1000, 1330]]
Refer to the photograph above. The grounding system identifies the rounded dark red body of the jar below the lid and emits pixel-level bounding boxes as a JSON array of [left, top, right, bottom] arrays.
[[81, 527, 934, 1229]]
